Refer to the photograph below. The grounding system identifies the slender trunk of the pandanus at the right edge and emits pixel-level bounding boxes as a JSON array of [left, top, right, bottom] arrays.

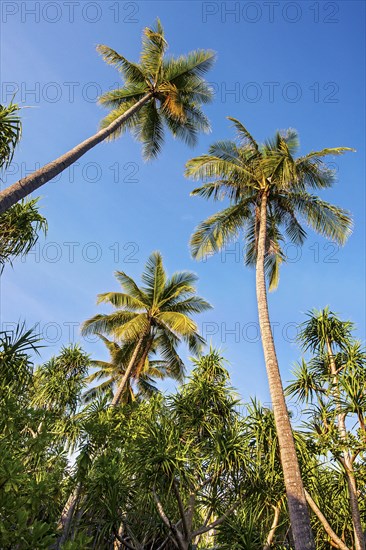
[[326, 340, 365, 550]]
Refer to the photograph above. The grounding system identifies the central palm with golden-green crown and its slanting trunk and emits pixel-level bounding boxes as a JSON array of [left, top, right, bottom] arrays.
[[82, 252, 211, 406]]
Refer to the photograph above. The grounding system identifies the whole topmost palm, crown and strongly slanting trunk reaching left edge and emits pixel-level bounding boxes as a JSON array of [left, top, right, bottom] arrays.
[[0, 20, 214, 214]]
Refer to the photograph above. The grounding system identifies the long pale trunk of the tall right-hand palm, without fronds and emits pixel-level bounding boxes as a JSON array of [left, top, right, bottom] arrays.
[[256, 192, 315, 550]]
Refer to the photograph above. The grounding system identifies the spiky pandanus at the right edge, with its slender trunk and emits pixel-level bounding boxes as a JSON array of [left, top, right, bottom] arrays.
[[287, 307, 366, 550]]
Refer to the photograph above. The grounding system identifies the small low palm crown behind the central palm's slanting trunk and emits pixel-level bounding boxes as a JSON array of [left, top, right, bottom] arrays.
[[84, 334, 184, 402]]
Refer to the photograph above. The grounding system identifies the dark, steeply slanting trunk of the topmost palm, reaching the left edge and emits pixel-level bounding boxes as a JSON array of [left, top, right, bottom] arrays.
[[0, 93, 152, 214]]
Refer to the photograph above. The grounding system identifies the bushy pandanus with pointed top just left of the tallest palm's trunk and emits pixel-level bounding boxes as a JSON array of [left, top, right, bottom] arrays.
[[121, 349, 250, 550]]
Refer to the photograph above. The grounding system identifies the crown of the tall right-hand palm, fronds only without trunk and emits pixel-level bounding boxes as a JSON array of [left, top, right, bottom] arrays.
[[186, 118, 352, 289]]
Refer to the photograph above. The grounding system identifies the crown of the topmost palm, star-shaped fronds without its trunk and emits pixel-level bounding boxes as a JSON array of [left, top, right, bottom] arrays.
[[97, 20, 214, 159]]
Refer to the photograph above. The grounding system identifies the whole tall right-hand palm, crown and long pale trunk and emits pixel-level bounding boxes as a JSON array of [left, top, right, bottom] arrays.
[[186, 119, 351, 550]]
